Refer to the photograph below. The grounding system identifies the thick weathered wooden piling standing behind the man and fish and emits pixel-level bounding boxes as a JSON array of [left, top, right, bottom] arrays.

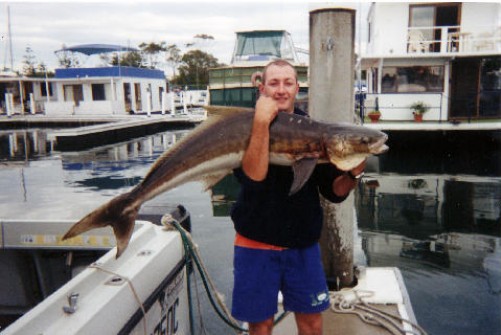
[[308, 8, 355, 289]]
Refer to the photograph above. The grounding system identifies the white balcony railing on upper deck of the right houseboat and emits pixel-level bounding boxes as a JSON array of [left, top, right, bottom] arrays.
[[407, 26, 501, 54]]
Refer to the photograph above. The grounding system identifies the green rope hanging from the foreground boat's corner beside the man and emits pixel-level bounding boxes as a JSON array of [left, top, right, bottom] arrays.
[[161, 214, 288, 333]]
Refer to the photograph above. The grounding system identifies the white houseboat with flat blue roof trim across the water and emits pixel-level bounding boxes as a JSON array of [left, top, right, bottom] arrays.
[[45, 66, 167, 115]]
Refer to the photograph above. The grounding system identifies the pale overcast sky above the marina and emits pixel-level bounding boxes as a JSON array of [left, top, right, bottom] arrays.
[[0, 0, 368, 74]]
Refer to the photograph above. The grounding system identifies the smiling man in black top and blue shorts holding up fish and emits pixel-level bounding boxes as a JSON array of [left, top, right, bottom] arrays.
[[231, 60, 365, 335]]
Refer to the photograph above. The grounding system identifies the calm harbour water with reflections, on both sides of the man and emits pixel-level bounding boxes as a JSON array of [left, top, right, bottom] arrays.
[[0, 130, 501, 334]]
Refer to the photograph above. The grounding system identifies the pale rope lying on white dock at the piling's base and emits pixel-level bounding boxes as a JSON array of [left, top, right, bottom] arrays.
[[330, 290, 427, 335]]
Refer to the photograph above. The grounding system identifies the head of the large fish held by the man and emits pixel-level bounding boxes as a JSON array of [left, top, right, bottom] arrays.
[[324, 124, 388, 171]]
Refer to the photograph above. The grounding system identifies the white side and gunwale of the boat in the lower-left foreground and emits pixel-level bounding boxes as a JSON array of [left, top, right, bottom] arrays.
[[2, 221, 190, 335]]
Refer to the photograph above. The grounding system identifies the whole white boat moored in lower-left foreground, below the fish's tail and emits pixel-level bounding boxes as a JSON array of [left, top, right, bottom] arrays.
[[0, 205, 191, 334]]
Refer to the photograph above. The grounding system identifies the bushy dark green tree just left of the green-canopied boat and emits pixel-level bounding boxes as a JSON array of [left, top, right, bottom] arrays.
[[172, 50, 221, 88]]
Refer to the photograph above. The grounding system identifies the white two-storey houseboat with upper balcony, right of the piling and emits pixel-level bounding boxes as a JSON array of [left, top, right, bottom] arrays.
[[361, 2, 501, 122]]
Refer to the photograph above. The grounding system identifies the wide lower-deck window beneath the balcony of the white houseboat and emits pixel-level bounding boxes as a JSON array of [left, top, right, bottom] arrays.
[[381, 66, 444, 93]]
